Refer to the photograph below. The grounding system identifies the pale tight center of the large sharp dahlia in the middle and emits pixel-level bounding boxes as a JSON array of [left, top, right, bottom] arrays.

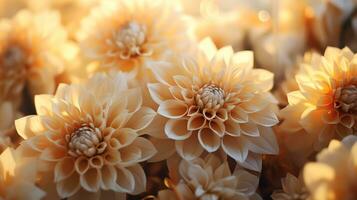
[[196, 84, 225, 109]]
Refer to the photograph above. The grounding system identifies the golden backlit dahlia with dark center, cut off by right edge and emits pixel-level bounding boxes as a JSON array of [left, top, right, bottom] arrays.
[[281, 47, 357, 150]]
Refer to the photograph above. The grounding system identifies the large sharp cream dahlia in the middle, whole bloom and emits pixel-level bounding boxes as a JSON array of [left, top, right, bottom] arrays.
[[148, 39, 278, 171]]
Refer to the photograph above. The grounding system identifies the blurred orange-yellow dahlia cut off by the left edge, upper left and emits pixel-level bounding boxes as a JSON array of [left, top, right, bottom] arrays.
[[0, 10, 73, 109]]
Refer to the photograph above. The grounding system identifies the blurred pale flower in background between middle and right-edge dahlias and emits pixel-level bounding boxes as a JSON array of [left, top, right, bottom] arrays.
[[248, 0, 306, 81]]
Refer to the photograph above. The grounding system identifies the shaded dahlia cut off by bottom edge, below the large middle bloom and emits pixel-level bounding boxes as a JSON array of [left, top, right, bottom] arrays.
[[152, 154, 261, 200]]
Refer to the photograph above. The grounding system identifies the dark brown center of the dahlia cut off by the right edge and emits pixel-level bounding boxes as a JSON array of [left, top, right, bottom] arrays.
[[335, 85, 357, 114]]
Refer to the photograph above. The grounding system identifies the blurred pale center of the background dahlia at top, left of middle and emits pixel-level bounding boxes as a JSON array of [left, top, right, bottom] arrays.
[[114, 22, 151, 60]]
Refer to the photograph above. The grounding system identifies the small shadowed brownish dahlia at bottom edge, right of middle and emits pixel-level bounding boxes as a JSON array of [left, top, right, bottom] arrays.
[[271, 173, 309, 200]]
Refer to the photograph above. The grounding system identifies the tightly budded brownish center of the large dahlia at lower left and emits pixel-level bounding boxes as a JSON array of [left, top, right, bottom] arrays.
[[66, 124, 107, 157]]
